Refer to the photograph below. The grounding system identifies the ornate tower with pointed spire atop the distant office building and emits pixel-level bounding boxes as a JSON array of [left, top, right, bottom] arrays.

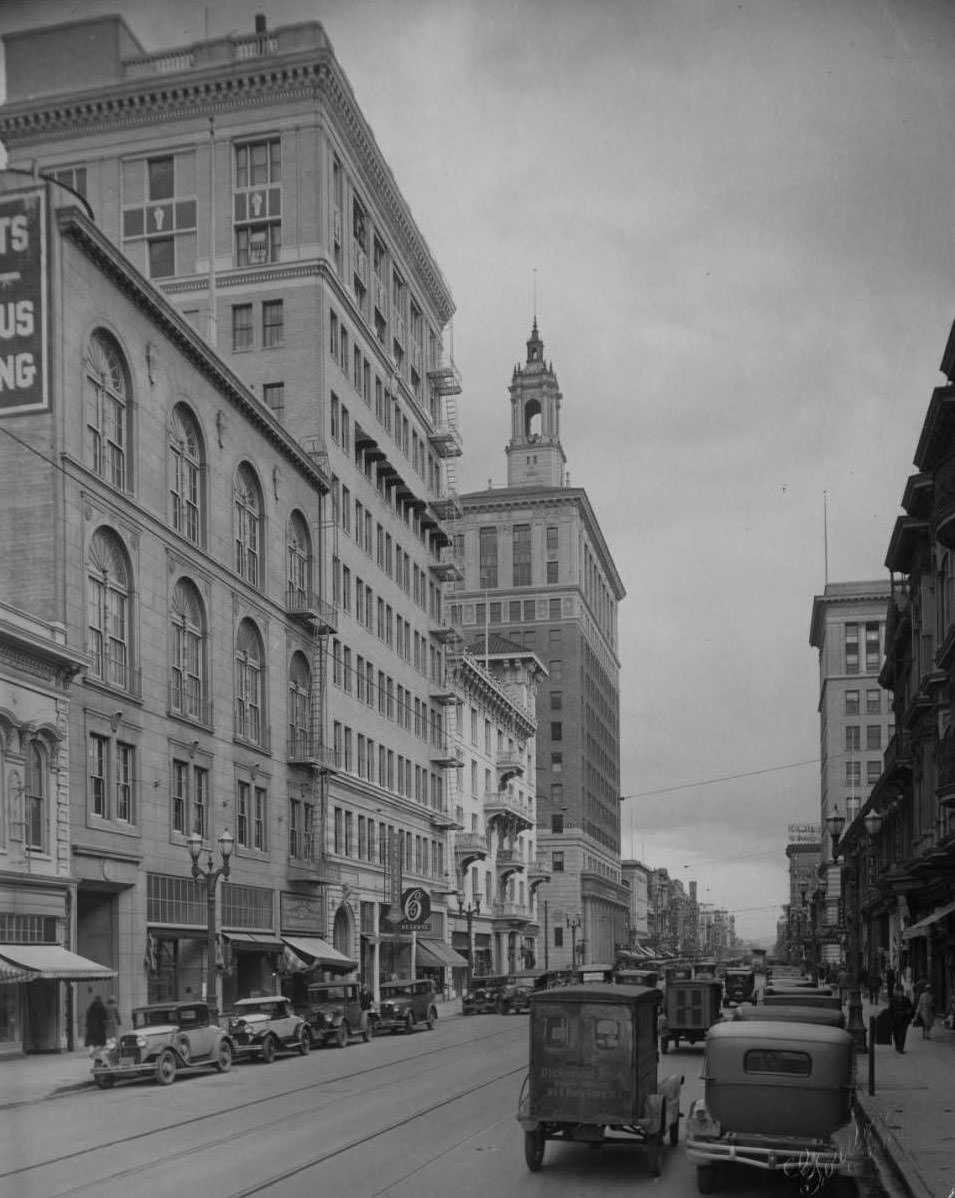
[[506, 316, 567, 486]]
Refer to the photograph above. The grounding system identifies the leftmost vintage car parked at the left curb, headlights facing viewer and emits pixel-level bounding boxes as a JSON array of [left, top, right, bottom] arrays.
[[92, 1003, 235, 1090]]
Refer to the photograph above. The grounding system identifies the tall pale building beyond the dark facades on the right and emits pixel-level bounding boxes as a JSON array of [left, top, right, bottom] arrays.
[[809, 580, 893, 964]]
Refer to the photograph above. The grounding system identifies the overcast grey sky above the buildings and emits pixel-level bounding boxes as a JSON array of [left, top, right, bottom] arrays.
[[0, 0, 955, 938]]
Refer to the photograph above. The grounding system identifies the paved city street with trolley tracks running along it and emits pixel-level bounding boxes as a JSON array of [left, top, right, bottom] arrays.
[[0, 1015, 891, 1198]]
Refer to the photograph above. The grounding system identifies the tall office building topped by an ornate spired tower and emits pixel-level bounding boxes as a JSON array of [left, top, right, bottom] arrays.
[[451, 321, 629, 968]]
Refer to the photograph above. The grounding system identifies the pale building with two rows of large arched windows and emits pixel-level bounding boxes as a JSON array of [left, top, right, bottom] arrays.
[[0, 171, 328, 1039]]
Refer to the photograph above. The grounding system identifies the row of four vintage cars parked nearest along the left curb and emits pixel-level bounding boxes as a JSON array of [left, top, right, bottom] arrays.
[[92, 979, 437, 1089]]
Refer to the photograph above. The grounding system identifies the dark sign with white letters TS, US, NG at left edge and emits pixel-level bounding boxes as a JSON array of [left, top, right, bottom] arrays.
[[0, 190, 48, 416]]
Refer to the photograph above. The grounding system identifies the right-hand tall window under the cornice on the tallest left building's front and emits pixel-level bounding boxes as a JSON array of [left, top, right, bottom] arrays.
[[232, 138, 282, 266]]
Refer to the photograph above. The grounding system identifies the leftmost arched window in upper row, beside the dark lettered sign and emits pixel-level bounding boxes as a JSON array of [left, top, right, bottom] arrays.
[[84, 332, 129, 491]]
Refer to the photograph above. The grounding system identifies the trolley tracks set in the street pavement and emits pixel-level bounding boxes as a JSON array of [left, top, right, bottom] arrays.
[[0, 1029, 526, 1193]]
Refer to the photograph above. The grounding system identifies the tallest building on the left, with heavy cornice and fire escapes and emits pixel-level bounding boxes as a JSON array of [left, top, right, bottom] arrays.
[[0, 9, 461, 1020]]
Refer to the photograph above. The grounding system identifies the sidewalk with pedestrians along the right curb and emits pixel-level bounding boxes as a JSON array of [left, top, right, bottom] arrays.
[[856, 1003, 955, 1198]]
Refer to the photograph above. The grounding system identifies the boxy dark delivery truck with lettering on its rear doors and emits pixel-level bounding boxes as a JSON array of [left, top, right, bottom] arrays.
[[518, 982, 683, 1176]]
